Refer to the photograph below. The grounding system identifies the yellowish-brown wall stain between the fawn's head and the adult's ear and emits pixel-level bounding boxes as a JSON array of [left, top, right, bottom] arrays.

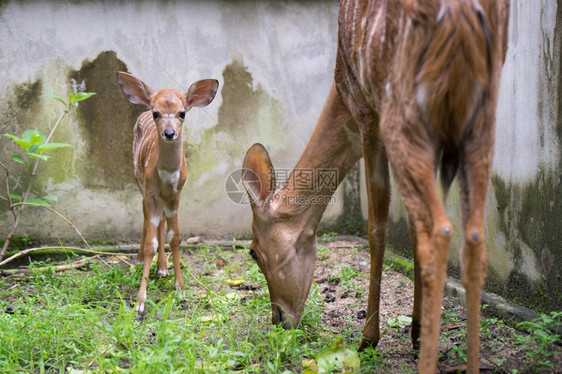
[[186, 58, 291, 198]]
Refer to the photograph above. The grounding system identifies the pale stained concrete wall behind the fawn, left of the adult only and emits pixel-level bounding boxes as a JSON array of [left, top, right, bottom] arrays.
[[0, 1, 341, 240]]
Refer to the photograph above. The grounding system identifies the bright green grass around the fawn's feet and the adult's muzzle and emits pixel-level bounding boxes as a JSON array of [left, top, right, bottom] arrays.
[[0, 247, 354, 373]]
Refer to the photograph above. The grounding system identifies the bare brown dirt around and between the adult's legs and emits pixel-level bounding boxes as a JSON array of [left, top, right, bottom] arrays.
[[306, 240, 562, 373]]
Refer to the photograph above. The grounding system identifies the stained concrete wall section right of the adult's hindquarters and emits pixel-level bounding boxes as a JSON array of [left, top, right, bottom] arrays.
[[488, 0, 562, 310]]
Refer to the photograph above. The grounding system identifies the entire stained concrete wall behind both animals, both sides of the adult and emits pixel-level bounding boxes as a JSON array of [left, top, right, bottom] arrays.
[[0, 0, 562, 309]]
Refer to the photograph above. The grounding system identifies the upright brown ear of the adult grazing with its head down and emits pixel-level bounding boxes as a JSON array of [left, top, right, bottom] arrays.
[[242, 143, 275, 208]]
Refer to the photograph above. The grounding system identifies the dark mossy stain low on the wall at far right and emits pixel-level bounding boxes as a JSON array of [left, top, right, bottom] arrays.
[[492, 169, 562, 309]]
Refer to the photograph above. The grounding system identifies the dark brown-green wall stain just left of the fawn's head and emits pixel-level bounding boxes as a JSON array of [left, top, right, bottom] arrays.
[[69, 51, 143, 189]]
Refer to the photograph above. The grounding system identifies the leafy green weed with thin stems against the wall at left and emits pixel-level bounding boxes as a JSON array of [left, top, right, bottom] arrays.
[[0, 92, 95, 261]]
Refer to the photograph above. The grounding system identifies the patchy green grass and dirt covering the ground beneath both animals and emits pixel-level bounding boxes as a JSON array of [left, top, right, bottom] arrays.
[[0, 243, 562, 374]]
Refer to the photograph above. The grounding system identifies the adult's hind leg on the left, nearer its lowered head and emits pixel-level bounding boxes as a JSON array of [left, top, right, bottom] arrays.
[[381, 109, 452, 373]]
